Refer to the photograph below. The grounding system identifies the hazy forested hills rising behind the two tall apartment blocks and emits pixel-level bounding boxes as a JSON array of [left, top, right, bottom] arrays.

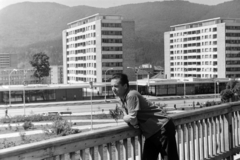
[[0, 0, 240, 66]]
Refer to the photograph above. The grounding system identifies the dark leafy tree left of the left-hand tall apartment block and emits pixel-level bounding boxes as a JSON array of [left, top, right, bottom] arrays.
[[30, 52, 51, 82]]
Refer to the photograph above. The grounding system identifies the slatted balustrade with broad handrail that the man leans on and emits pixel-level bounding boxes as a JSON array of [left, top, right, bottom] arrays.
[[0, 102, 240, 160]]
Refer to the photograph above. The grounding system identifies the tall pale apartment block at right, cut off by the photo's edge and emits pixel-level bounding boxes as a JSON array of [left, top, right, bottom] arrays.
[[164, 18, 240, 79]]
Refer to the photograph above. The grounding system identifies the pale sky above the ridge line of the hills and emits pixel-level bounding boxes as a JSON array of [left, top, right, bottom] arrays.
[[0, 0, 231, 9]]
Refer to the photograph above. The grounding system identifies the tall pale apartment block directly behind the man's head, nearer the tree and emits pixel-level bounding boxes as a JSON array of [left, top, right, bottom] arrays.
[[63, 14, 135, 84]]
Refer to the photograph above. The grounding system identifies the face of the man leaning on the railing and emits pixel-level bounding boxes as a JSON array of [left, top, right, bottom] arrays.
[[111, 78, 127, 98]]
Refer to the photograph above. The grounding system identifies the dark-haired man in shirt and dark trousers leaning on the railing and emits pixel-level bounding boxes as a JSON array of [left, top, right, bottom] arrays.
[[111, 73, 179, 160]]
